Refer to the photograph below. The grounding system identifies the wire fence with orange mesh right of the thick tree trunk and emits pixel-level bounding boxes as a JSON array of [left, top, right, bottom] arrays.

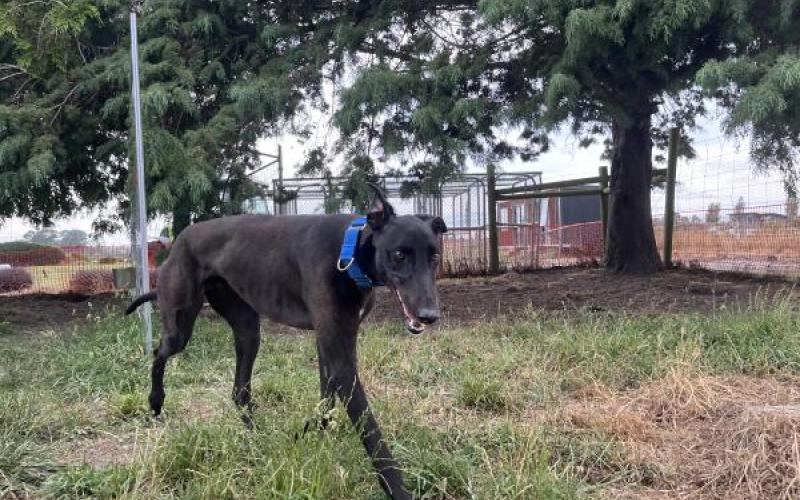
[[664, 137, 800, 279]]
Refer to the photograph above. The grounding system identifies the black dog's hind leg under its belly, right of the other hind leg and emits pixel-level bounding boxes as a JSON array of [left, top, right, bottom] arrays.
[[205, 279, 261, 427]]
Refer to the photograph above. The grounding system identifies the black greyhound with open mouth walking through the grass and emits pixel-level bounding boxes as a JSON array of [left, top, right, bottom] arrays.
[[126, 186, 447, 499]]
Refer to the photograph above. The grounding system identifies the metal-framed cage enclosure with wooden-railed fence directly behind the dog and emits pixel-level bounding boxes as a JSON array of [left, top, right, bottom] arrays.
[[248, 172, 636, 276]]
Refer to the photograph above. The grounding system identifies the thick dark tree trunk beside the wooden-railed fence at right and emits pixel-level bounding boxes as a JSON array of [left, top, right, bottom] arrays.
[[605, 106, 662, 274]]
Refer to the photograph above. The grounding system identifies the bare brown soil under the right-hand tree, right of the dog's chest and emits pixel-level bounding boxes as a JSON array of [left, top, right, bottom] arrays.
[[371, 268, 793, 324]]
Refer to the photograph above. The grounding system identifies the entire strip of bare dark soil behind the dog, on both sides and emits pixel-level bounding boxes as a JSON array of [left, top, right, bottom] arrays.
[[0, 268, 795, 331]]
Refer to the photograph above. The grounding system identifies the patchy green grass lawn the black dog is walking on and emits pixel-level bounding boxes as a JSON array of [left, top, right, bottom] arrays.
[[0, 302, 800, 499]]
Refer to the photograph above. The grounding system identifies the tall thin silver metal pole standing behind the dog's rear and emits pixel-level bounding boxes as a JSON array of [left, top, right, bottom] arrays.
[[131, 4, 153, 356]]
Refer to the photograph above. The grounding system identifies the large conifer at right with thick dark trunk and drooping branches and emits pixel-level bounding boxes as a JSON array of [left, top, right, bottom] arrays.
[[258, 0, 800, 273]]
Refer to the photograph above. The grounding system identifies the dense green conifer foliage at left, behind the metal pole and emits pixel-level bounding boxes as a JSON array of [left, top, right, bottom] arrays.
[[0, 0, 298, 232]]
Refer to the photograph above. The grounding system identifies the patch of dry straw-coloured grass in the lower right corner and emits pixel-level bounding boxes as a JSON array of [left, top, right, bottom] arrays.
[[546, 368, 800, 499]]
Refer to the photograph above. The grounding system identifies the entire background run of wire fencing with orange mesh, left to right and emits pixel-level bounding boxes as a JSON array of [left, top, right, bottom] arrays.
[[0, 138, 800, 294]]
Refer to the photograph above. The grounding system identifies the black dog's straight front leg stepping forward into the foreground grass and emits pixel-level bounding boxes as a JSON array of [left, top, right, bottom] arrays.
[[318, 330, 411, 499]]
